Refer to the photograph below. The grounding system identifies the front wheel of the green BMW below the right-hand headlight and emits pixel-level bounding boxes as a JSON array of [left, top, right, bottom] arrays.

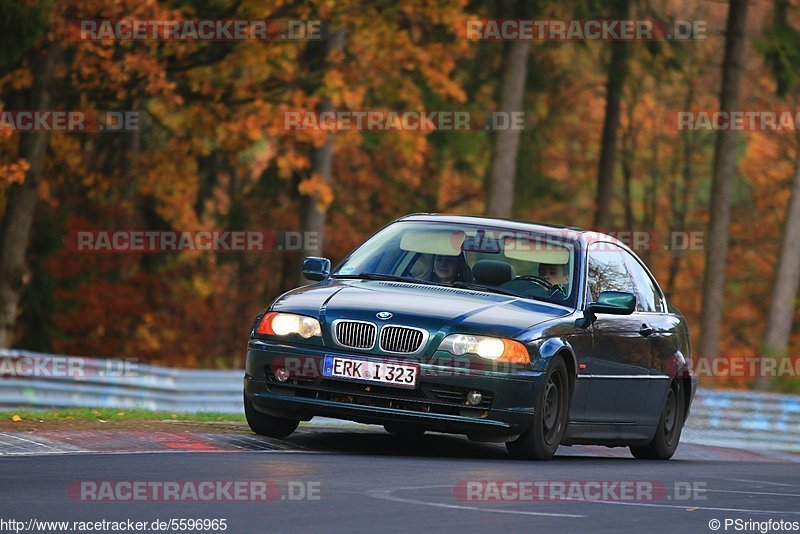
[[506, 356, 570, 460]]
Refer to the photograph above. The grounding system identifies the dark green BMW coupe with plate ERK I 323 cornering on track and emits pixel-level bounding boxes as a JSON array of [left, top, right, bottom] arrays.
[[244, 214, 697, 460]]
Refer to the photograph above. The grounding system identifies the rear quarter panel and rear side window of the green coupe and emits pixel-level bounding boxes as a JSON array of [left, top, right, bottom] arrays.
[[623, 251, 680, 425]]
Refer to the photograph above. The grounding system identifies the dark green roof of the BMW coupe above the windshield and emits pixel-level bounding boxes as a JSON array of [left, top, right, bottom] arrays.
[[397, 213, 629, 250]]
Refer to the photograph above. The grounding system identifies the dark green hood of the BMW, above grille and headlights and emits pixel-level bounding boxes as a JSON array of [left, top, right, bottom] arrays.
[[272, 280, 570, 338]]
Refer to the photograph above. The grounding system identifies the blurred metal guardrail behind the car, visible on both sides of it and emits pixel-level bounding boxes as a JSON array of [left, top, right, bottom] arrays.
[[0, 349, 800, 452]]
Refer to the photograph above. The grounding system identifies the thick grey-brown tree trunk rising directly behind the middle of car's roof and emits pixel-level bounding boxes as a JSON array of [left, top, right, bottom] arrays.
[[486, 41, 531, 217]]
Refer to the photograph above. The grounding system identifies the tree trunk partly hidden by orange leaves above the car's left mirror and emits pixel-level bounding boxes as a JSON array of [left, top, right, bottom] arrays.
[[301, 30, 345, 272]]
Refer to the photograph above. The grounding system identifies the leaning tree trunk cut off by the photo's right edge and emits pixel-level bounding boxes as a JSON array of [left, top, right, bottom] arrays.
[[756, 148, 800, 388]]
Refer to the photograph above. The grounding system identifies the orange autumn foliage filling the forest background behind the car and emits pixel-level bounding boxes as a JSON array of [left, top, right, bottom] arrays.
[[0, 0, 800, 385]]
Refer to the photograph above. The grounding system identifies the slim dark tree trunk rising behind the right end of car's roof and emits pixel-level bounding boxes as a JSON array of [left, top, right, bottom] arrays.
[[594, 0, 631, 229]]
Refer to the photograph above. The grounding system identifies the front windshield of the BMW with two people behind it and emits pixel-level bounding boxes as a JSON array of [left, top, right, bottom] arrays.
[[333, 221, 576, 305]]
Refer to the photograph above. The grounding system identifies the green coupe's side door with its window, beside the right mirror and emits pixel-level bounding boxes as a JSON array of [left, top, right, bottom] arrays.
[[584, 242, 651, 424]]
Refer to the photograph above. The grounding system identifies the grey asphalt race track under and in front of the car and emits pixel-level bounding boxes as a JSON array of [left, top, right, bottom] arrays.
[[0, 427, 800, 533]]
